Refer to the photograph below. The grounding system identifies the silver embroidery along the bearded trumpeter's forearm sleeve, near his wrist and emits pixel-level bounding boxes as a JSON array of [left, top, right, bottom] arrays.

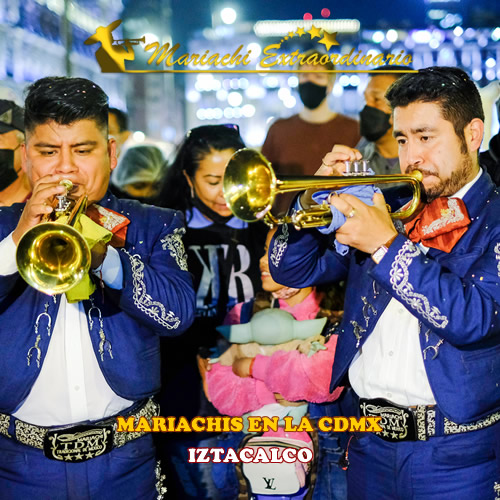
[[390, 241, 448, 328]]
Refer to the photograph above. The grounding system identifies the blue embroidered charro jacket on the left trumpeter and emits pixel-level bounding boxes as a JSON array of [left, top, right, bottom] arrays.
[[0, 192, 195, 413]]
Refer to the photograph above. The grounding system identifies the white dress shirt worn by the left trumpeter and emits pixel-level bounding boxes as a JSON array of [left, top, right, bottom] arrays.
[[0, 234, 134, 426]]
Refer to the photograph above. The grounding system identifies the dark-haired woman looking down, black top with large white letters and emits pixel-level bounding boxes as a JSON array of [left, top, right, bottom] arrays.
[[156, 124, 267, 500]]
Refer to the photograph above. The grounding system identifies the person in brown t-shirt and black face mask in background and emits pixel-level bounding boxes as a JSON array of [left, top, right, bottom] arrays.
[[262, 50, 360, 182]]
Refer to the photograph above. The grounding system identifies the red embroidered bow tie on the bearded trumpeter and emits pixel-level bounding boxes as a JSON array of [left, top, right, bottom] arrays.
[[405, 198, 470, 253]]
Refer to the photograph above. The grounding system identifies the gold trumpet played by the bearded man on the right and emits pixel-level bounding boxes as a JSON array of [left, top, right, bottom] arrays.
[[223, 148, 423, 228]]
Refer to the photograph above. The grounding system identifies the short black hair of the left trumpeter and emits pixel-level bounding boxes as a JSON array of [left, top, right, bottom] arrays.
[[24, 76, 108, 135]]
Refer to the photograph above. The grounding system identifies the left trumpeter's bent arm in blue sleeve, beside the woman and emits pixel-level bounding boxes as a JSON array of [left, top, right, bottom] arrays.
[[118, 209, 195, 335]]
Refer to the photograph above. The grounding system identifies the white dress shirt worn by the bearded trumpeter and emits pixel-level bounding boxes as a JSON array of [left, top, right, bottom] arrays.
[[349, 169, 482, 406]]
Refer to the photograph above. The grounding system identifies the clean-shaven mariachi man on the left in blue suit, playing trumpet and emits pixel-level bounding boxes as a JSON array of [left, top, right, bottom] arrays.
[[0, 77, 194, 500]]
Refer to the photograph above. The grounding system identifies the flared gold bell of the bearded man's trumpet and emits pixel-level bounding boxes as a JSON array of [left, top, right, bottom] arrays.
[[223, 149, 277, 222]]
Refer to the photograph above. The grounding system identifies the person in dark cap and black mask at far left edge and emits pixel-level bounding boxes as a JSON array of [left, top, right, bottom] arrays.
[[0, 99, 31, 206]]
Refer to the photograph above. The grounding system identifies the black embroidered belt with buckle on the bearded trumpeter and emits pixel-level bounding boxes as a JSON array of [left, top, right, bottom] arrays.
[[359, 398, 500, 442]]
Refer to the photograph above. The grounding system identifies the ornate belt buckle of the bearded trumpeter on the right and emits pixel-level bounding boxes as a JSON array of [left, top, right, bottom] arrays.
[[359, 398, 417, 443]]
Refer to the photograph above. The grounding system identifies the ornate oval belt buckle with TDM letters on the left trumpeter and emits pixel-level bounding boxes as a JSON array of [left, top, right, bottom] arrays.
[[43, 425, 113, 462]]
